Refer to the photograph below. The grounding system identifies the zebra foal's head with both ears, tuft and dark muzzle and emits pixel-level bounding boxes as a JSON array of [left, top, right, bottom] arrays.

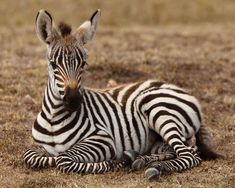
[[36, 10, 101, 111]]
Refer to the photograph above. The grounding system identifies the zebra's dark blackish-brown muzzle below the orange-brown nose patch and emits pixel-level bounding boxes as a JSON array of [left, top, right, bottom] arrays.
[[64, 87, 82, 111]]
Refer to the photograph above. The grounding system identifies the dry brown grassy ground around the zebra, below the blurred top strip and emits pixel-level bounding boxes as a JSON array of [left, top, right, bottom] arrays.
[[0, 1, 235, 187]]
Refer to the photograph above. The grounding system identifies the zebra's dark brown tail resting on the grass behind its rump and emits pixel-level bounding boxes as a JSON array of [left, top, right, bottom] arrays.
[[196, 125, 224, 160]]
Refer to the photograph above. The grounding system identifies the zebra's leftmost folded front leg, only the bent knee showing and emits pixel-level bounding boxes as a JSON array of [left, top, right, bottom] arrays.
[[23, 146, 55, 169]]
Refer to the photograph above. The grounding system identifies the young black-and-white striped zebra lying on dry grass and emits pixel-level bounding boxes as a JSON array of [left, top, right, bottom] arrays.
[[23, 9, 219, 180]]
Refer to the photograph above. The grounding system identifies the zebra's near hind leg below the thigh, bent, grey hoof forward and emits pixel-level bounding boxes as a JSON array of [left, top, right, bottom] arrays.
[[145, 132, 201, 180]]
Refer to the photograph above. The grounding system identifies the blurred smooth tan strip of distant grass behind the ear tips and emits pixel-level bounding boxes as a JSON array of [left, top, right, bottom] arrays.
[[0, 0, 235, 27]]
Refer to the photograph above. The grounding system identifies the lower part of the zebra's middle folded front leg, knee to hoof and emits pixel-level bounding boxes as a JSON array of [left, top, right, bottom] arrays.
[[56, 150, 137, 174]]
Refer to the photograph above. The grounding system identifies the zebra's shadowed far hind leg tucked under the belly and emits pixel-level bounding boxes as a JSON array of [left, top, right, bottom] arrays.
[[131, 141, 176, 170]]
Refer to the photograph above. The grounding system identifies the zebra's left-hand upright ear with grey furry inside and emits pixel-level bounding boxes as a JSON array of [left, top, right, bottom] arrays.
[[36, 9, 53, 44]]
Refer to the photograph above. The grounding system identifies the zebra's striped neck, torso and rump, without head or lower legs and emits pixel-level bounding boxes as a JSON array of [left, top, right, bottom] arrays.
[[32, 81, 201, 158]]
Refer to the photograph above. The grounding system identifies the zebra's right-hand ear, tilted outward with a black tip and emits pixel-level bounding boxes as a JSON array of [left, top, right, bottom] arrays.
[[74, 9, 101, 44]]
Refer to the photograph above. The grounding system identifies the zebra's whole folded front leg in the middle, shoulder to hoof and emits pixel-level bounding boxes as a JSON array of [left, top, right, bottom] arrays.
[[56, 130, 137, 173]]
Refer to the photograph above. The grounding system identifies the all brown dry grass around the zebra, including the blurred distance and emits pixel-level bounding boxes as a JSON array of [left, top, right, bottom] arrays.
[[0, 0, 235, 187]]
